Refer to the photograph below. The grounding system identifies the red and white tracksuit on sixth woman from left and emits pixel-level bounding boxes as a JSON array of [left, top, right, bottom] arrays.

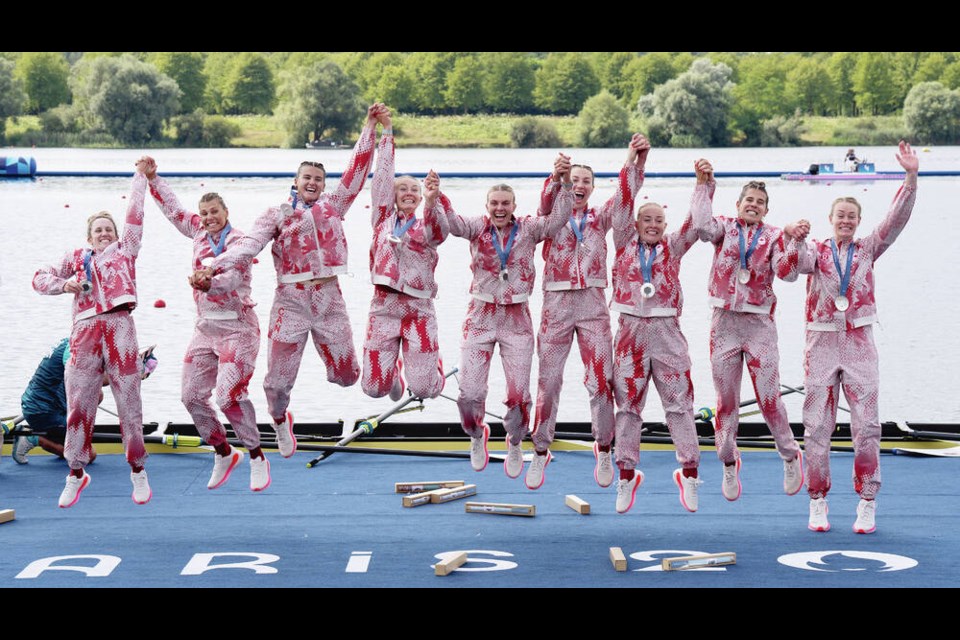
[[532, 164, 643, 451]]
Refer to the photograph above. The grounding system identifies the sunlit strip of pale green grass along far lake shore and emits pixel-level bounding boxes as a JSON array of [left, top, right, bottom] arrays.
[[7, 115, 905, 148]]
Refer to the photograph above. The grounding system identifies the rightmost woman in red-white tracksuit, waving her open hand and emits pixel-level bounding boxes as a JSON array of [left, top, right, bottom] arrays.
[[784, 141, 920, 533]]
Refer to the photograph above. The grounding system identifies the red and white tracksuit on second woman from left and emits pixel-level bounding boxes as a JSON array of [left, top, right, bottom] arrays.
[[150, 177, 260, 449]]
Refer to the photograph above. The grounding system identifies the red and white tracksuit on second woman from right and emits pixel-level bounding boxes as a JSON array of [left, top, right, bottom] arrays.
[[694, 209, 800, 464]]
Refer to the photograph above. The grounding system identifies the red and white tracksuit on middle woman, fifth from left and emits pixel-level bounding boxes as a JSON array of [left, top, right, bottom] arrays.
[[438, 183, 573, 444]]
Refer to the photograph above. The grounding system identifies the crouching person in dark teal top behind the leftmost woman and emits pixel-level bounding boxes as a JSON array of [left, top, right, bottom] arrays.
[[11, 338, 157, 464]]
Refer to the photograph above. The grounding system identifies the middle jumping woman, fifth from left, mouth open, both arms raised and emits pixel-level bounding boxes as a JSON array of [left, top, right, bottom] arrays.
[[437, 165, 573, 478]]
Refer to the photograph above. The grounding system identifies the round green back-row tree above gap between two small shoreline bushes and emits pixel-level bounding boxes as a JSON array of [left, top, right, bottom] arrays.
[[533, 51, 600, 113]]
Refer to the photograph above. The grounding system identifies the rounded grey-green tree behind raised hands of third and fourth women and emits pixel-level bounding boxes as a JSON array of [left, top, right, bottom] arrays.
[[277, 60, 366, 148]]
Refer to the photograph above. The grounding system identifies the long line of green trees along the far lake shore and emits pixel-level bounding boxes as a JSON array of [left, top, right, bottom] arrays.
[[0, 52, 960, 147]]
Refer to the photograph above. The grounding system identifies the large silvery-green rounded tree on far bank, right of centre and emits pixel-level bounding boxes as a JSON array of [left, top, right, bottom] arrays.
[[638, 58, 733, 147]]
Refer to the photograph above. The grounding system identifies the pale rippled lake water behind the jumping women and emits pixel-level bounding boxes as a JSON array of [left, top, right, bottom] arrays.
[[0, 147, 960, 430]]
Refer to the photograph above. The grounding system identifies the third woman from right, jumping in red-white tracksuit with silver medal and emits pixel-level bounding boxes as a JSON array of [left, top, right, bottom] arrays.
[[610, 159, 717, 513]]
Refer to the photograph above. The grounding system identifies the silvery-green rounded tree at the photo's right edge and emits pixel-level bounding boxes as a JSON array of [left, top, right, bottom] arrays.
[[903, 82, 960, 144]]
